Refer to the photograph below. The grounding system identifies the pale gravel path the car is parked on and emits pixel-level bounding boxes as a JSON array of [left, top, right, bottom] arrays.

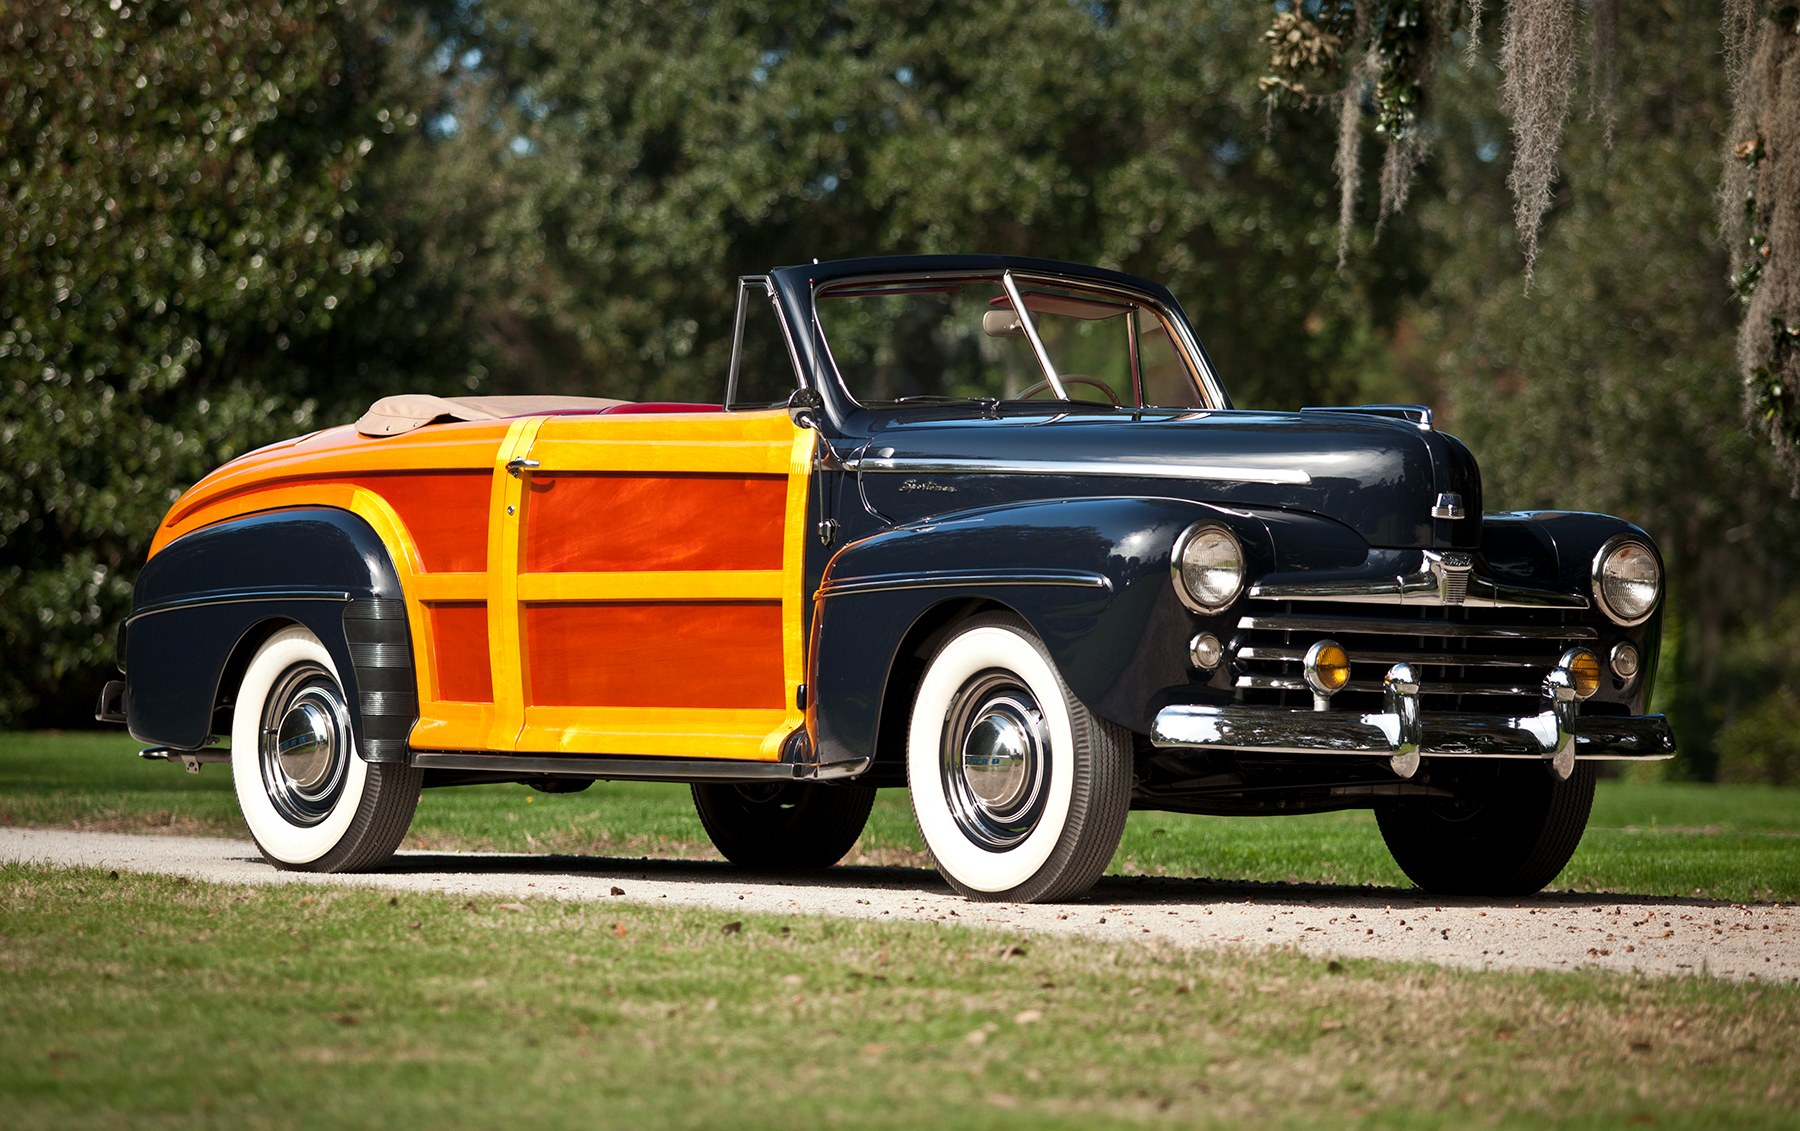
[[0, 828, 1800, 982]]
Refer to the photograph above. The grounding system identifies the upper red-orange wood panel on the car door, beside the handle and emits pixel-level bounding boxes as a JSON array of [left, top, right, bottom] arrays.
[[524, 472, 787, 573]]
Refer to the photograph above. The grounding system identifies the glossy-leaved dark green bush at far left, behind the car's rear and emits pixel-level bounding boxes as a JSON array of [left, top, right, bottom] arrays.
[[0, 0, 493, 720]]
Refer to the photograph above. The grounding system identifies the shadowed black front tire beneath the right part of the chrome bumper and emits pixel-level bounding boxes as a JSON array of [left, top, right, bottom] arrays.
[[1375, 762, 1595, 895]]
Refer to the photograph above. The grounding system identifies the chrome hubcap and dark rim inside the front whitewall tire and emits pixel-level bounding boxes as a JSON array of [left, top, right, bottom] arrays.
[[940, 672, 1049, 852]]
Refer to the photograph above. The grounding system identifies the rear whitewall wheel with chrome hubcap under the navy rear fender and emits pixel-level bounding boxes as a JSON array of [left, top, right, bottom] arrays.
[[230, 627, 423, 872]]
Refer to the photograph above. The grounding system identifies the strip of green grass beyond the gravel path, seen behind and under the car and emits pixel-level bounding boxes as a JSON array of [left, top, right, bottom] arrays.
[[0, 733, 1800, 900]]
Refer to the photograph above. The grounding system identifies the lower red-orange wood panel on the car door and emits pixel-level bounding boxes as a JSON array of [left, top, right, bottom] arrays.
[[524, 602, 787, 710]]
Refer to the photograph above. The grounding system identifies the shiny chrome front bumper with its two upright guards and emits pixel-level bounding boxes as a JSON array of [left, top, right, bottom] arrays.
[[1150, 663, 1676, 780]]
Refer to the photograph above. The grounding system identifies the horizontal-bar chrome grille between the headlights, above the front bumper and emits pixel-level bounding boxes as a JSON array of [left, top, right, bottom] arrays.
[[1229, 602, 1597, 713]]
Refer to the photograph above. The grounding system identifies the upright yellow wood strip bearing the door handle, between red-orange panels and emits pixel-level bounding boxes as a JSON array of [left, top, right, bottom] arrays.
[[486, 416, 544, 751]]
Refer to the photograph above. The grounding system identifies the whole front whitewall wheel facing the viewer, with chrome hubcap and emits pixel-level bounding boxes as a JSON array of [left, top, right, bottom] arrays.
[[907, 614, 1132, 902]]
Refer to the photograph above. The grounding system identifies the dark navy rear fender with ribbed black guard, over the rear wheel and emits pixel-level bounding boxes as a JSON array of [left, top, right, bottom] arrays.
[[124, 508, 418, 762]]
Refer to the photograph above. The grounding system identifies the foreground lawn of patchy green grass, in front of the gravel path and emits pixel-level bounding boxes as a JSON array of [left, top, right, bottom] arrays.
[[0, 864, 1800, 1131]]
